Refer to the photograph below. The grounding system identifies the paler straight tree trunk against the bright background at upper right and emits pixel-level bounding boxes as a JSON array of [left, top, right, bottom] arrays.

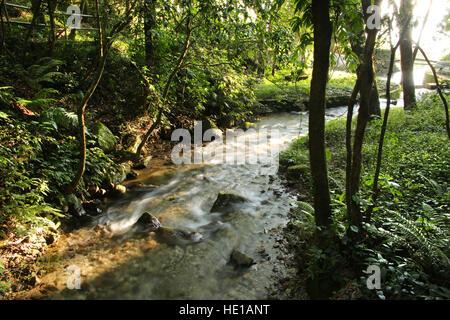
[[400, 0, 417, 109]]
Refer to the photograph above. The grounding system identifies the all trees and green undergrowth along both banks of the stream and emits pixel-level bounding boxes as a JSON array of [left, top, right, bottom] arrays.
[[0, 0, 450, 299]]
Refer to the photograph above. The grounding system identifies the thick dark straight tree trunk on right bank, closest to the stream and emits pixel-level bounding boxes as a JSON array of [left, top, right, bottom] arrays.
[[309, 0, 332, 227]]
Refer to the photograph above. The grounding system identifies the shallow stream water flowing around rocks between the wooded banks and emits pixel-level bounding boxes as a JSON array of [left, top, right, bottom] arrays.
[[26, 107, 346, 299]]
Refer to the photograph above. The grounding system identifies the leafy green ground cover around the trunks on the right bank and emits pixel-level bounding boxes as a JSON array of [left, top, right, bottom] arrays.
[[280, 95, 450, 299]]
